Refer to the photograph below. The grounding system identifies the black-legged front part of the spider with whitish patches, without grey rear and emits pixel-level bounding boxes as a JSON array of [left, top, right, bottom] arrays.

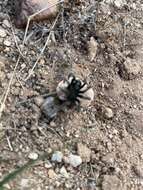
[[57, 74, 94, 106]]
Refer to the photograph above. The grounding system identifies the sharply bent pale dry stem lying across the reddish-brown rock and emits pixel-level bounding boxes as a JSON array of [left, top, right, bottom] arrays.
[[23, 0, 64, 45]]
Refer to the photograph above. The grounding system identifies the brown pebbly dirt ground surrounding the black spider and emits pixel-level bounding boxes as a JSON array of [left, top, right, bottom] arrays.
[[0, 0, 143, 190]]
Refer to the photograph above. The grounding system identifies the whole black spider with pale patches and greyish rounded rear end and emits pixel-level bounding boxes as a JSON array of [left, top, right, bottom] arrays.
[[42, 74, 94, 120]]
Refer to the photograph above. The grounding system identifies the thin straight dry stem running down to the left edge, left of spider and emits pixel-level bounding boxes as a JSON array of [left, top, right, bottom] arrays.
[[0, 55, 21, 118]]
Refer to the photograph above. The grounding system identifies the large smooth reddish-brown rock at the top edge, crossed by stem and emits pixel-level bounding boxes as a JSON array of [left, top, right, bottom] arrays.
[[16, 0, 59, 28]]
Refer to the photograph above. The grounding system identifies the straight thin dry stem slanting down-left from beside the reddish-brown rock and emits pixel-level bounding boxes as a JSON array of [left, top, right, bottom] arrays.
[[24, 13, 60, 81]]
